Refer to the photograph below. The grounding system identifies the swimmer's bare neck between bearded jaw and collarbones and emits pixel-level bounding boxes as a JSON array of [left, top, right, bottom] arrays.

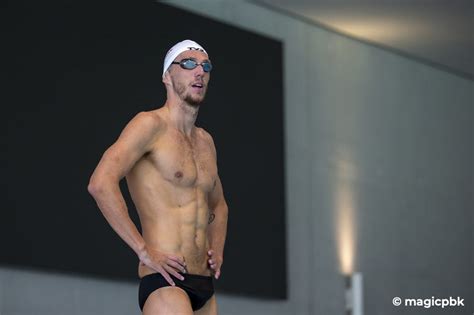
[[165, 99, 199, 136]]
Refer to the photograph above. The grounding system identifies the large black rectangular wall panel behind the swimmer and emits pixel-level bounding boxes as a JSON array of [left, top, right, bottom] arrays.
[[0, 1, 286, 298]]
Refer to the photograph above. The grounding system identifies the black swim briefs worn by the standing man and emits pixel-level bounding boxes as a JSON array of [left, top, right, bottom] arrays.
[[138, 273, 214, 311]]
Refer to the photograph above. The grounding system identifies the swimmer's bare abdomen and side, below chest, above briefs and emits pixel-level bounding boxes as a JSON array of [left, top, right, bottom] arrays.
[[127, 164, 210, 278]]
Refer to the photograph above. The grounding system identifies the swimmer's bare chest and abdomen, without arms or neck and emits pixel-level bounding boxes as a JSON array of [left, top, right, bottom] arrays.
[[126, 109, 217, 277]]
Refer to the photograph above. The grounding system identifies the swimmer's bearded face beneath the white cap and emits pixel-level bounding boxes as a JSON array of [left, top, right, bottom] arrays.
[[168, 50, 210, 107]]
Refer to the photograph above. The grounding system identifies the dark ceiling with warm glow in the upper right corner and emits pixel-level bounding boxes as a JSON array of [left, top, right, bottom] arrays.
[[252, 0, 474, 80]]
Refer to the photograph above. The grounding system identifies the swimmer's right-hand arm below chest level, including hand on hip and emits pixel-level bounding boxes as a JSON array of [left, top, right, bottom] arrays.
[[208, 177, 228, 279]]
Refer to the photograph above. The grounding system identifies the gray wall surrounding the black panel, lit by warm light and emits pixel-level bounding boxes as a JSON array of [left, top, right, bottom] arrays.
[[0, 1, 474, 315]]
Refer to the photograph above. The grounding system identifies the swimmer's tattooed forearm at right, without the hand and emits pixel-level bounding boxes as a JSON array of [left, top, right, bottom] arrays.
[[208, 202, 228, 257]]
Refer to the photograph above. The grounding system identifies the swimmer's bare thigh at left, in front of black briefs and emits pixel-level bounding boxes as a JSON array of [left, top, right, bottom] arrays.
[[143, 287, 193, 315]]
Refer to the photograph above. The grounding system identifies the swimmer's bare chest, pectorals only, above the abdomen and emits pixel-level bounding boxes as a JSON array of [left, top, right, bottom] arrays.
[[149, 133, 217, 192]]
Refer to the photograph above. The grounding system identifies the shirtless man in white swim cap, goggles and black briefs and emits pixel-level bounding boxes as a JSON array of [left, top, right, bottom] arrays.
[[88, 40, 228, 315]]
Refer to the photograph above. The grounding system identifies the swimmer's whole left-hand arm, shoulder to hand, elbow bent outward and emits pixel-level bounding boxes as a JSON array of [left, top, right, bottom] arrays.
[[88, 112, 184, 284]]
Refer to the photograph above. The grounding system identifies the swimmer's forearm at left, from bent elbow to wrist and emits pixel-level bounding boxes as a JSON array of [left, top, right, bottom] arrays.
[[89, 183, 145, 257]]
